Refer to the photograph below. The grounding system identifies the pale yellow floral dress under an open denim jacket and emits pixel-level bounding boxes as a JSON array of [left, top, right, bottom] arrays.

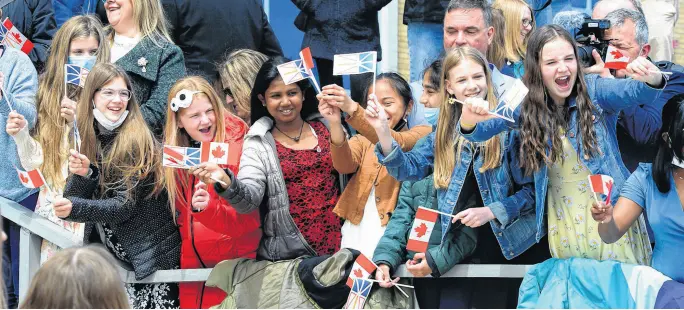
[[546, 130, 652, 265]]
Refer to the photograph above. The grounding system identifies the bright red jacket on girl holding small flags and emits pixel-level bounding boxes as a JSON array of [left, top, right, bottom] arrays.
[[176, 114, 261, 309]]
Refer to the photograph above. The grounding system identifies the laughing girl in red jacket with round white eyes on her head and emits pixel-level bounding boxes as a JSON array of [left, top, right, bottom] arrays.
[[164, 76, 261, 309]]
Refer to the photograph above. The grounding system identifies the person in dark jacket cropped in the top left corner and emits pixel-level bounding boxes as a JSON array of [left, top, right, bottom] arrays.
[[0, 0, 57, 73]]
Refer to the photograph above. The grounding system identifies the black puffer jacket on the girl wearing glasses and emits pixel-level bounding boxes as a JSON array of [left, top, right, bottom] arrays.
[[64, 124, 181, 280]]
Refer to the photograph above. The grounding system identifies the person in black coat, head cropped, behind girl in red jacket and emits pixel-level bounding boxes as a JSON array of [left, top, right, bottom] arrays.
[[161, 0, 283, 82]]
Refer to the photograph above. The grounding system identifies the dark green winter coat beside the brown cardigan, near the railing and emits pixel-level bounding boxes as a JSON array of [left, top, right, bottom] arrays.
[[373, 175, 477, 277]]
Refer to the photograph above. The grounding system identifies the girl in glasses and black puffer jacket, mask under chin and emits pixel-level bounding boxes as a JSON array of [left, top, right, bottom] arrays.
[[53, 63, 181, 308]]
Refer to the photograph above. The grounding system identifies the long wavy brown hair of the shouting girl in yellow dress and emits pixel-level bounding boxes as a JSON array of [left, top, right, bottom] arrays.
[[520, 25, 598, 175]]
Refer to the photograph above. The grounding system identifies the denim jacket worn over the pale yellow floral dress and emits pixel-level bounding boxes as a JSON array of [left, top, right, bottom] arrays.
[[458, 73, 668, 241]]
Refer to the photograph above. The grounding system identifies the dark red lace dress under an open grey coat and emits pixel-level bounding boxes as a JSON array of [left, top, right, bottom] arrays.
[[276, 121, 342, 255]]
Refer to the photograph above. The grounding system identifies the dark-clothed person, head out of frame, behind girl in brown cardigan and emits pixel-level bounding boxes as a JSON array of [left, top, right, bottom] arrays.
[[292, 0, 392, 106]]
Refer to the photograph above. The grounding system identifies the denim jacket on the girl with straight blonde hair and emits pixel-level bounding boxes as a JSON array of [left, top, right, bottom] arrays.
[[375, 132, 536, 259]]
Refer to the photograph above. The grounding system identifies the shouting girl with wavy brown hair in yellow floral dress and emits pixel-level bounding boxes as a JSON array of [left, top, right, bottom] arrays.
[[461, 25, 677, 264]]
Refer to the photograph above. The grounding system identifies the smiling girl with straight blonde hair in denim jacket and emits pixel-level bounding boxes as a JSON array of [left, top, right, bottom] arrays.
[[366, 47, 541, 308]]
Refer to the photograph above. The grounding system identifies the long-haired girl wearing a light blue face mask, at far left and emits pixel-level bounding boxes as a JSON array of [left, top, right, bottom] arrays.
[[7, 15, 109, 263]]
